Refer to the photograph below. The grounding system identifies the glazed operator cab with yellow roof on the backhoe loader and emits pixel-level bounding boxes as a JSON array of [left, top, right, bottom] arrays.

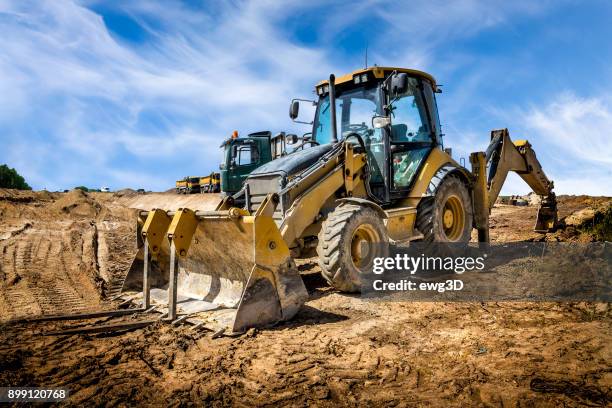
[[290, 67, 442, 204]]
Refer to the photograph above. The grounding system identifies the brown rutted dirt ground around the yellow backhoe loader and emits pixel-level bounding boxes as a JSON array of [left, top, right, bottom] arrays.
[[0, 190, 612, 407]]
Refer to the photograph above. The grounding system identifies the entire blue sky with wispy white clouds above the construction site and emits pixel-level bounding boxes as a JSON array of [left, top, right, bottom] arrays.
[[0, 0, 612, 195]]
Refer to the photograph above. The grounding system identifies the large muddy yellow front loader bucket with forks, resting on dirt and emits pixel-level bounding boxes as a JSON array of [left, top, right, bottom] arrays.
[[124, 208, 308, 332]]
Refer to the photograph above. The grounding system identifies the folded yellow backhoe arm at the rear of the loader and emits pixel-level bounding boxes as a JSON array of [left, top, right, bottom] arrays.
[[485, 129, 557, 232]]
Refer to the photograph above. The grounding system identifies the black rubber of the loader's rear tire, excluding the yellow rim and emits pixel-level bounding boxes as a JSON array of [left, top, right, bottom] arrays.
[[415, 175, 474, 242]]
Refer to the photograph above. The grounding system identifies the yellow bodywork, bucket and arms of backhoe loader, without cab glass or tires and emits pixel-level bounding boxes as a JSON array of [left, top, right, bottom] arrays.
[[123, 67, 556, 332]]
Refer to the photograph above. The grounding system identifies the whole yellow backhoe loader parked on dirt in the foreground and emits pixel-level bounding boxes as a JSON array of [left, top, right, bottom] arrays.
[[123, 67, 557, 332]]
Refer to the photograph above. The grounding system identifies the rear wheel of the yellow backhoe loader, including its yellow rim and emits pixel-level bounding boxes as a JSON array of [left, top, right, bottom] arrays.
[[416, 175, 473, 242]]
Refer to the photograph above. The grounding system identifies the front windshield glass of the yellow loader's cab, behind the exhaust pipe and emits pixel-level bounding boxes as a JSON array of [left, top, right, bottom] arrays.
[[313, 86, 381, 144]]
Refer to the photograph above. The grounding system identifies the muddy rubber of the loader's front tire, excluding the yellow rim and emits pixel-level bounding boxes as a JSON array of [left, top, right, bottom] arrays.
[[317, 203, 389, 292]]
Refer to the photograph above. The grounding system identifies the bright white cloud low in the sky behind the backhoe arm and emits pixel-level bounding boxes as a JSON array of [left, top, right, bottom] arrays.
[[492, 91, 612, 196]]
